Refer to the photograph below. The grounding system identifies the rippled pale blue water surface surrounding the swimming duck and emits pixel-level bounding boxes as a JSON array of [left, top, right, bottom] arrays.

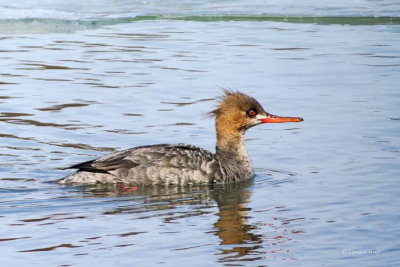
[[0, 1, 400, 266]]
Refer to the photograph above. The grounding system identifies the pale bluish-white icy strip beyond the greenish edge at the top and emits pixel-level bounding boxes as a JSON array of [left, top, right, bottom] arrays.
[[0, 0, 400, 19]]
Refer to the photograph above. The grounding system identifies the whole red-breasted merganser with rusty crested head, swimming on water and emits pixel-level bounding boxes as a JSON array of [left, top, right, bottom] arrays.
[[58, 91, 303, 185]]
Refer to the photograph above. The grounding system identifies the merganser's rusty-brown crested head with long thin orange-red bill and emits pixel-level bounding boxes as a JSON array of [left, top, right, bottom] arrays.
[[210, 90, 303, 137]]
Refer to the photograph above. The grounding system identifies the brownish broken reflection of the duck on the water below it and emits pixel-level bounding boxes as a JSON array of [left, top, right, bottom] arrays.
[[87, 179, 262, 249]]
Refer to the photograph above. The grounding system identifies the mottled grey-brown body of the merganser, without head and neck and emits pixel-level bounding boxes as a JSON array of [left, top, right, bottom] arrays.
[[60, 144, 253, 185]]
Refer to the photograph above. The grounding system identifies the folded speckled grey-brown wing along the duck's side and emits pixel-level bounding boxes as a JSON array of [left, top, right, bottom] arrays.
[[65, 144, 220, 184]]
